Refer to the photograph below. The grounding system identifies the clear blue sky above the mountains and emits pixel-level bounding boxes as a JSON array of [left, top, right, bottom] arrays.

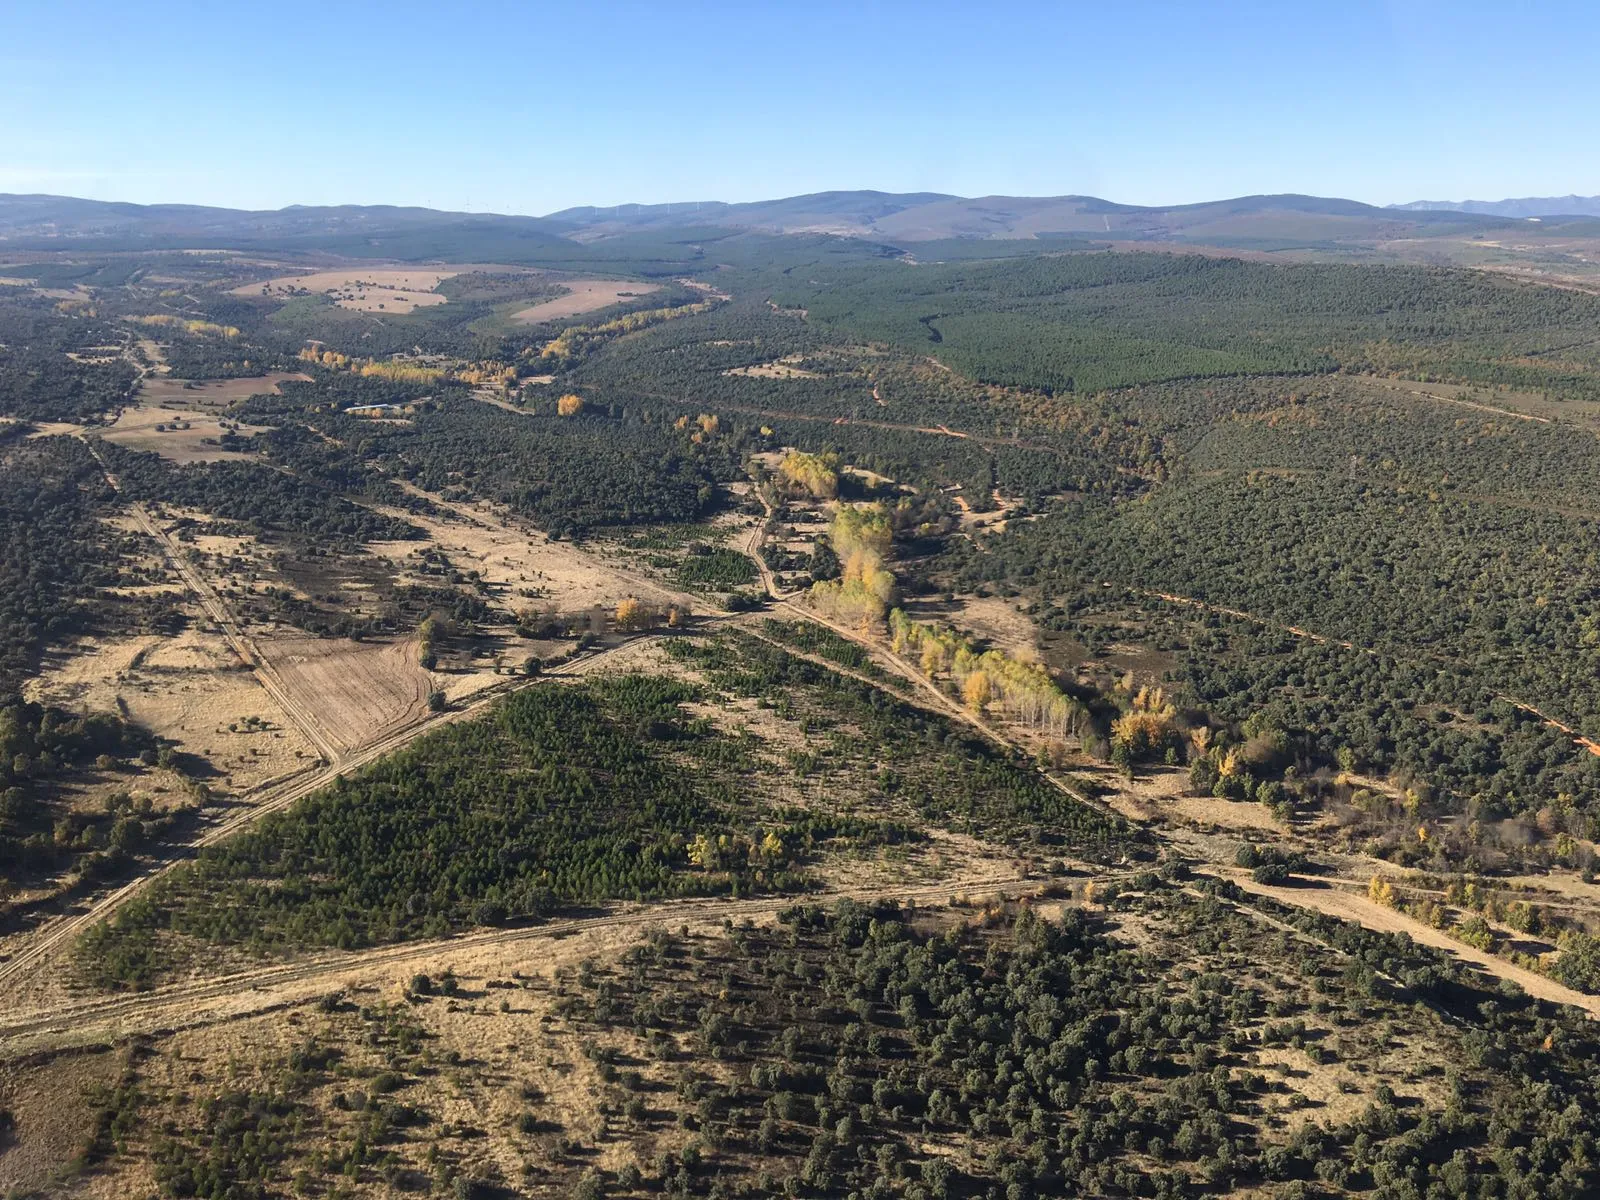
[[0, 0, 1600, 213]]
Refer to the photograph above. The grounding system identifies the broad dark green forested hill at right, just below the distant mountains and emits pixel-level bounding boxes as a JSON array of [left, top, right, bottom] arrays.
[[774, 254, 1600, 397]]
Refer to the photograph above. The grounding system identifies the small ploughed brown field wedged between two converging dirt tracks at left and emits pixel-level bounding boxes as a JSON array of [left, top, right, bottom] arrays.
[[258, 635, 432, 750]]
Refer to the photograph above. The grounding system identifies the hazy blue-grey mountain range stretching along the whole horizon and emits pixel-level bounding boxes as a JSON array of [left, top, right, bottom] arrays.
[[0, 190, 1600, 262]]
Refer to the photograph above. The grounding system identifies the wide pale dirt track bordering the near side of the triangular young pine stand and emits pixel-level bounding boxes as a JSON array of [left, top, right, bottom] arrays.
[[0, 870, 1038, 1059]]
